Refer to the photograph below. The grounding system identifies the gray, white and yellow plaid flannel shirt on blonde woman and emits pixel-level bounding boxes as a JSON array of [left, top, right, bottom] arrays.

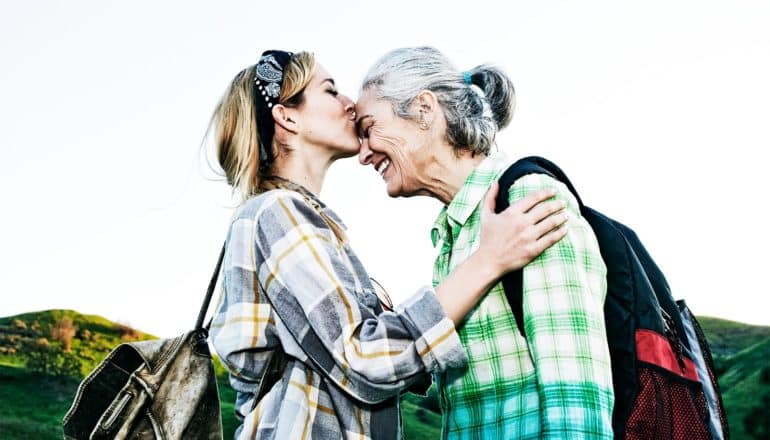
[[211, 189, 467, 439]]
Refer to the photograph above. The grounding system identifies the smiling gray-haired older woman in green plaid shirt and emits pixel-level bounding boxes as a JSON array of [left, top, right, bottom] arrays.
[[356, 47, 613, 439]]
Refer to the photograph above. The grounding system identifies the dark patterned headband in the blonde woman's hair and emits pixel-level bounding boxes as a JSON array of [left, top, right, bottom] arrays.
[[252, 50, 294, 172]]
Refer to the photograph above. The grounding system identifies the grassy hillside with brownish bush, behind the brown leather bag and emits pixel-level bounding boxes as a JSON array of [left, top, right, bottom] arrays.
[[0, 310, 238, 439]]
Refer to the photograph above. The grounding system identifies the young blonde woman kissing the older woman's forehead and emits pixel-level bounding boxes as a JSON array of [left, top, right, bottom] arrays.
[[211, 51, 566, 439]]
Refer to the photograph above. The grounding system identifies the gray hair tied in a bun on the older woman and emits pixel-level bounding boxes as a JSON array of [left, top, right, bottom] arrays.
[[361, 47, 515, 155]]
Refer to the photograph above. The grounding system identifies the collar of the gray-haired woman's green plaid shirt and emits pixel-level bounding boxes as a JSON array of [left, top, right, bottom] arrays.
[[431, 151, 510, 247]]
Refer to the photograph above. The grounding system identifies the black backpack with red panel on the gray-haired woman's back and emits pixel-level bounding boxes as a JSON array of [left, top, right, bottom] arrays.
[[496, 156, 729, 440]]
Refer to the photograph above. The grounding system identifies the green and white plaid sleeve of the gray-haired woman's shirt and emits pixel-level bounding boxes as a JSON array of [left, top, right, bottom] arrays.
[[509, 174, 614, 439]]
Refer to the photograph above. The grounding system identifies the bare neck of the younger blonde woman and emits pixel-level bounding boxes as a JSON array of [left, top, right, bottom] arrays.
[[273, 146, 334, 196]]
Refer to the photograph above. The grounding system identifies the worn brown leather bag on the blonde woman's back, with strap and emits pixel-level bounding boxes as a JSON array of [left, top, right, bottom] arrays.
[[63, 248, 224, 440]]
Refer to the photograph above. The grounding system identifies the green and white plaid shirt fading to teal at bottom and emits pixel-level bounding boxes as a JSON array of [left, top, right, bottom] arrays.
[[431, 153, 614, 439]]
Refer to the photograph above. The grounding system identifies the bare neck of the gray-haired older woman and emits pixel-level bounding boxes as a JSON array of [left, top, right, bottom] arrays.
[[421, 145, 486, 205]]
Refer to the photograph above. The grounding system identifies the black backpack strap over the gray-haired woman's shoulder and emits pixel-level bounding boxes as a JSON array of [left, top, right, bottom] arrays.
[[495, 156, 584, 338]]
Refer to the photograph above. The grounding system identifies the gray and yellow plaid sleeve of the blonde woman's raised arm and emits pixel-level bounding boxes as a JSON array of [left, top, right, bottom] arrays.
[[255, 191, 467, 403]]
